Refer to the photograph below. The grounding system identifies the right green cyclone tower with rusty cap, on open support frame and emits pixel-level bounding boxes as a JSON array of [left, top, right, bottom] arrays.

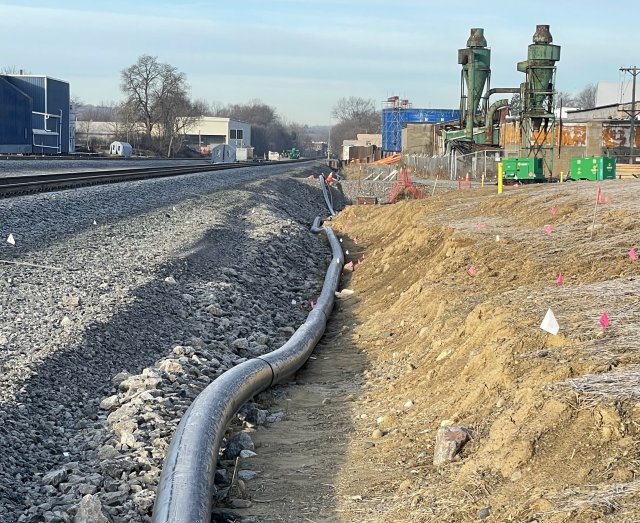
[[518, 25, 560, 180]]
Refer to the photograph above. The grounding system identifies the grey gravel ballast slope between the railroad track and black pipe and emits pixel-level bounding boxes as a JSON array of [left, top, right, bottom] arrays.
[[0, 164, 338, 523]]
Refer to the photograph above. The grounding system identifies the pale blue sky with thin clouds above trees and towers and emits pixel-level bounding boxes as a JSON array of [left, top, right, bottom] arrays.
[[0, 0, 640, 124]]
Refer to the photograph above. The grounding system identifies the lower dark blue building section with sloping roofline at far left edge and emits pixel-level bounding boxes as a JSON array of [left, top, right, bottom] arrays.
[[0, 76, 32, 154]]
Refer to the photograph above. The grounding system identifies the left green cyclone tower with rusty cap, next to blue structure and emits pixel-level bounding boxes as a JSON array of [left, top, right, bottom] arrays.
[[458, 28, 491, 140]]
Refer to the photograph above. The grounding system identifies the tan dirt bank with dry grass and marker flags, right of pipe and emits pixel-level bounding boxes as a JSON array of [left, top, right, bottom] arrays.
[[239, 180, 640, 523]]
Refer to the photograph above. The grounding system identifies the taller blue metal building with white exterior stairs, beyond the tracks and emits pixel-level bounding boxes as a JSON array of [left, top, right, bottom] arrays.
[[1, 75, 73, 154]]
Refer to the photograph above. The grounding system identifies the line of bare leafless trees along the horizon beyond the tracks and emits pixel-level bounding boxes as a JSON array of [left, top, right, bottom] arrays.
[[74, 55, 381, 156]]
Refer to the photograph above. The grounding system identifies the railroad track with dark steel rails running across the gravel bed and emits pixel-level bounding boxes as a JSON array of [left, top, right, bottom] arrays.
[[0, 160, 308, 197]]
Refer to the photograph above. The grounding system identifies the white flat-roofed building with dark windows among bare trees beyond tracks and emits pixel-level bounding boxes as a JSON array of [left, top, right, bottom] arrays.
[[186, 116, 251, 154]]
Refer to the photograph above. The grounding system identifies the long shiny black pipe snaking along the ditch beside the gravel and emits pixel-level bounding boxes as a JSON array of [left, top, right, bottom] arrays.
[[152, 179, 344, 523]]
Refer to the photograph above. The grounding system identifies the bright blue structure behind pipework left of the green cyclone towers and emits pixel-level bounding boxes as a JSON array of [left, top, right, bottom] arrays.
[[382, 107, 460, 153]]
